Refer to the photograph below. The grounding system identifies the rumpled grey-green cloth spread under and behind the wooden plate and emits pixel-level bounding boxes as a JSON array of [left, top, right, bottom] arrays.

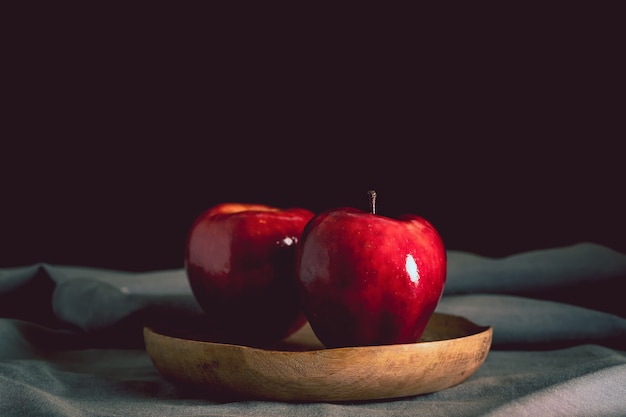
[[0, 243, 626, 417]]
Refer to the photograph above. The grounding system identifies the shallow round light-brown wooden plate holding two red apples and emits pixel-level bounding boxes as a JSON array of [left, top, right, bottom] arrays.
[[144, 313, 493, 401]]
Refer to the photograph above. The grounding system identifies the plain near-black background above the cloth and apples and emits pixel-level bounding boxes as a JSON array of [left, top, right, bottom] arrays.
[[0, 5, 626, 271]]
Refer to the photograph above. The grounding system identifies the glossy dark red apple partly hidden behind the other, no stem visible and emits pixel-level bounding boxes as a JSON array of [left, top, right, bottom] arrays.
[[185, 203, 313, 345]]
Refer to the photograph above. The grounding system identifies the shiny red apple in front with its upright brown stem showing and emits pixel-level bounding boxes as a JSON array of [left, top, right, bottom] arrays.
[[296, 192, 447, 348]]
